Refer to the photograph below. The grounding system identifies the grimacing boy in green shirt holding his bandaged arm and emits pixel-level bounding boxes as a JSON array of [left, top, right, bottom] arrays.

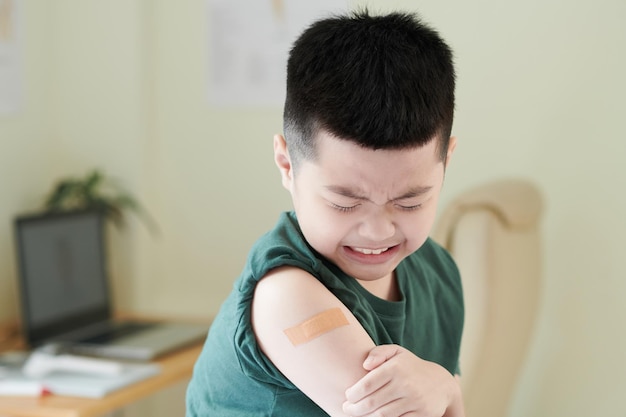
[[187, 12, 464, 417]]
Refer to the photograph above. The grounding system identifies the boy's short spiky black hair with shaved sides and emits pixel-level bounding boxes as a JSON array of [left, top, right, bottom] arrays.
[[283, 10, 455, 169]]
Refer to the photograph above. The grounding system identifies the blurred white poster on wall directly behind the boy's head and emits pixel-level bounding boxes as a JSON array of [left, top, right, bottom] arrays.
[[208, 0, 348, 107]]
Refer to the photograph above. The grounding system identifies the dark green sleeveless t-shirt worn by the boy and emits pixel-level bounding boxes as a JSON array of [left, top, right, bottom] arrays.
[[187, 212, 464, 417]]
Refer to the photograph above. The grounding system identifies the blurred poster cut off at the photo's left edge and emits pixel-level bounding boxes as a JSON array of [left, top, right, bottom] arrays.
[[0, 0, 22, 114]]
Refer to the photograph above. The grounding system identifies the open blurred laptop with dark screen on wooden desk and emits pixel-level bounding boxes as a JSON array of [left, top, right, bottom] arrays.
[[14, 210, 209, 361]]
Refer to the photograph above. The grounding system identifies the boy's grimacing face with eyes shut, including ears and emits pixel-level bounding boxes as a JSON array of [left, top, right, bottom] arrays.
[[274, 132, 456, 287]]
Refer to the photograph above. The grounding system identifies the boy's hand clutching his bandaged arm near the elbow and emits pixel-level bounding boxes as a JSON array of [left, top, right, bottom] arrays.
[[343, 345, 464, 417]]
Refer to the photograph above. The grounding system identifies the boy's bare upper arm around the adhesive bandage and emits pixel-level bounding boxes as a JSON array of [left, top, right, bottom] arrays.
[[252, 267, 375, 416]]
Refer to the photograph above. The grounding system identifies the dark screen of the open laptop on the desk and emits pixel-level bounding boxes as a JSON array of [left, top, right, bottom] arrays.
[[15, 211, 110, 345]]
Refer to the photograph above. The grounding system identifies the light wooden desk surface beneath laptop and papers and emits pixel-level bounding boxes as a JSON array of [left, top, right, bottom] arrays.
[[0, 343, 202, 417]]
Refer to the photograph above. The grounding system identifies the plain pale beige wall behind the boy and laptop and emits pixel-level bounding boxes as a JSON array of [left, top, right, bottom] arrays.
[[0, 0, 626, 417]]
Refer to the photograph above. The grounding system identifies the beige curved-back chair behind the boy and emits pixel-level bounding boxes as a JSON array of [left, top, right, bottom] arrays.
[[432, 180, 543, 417]]
